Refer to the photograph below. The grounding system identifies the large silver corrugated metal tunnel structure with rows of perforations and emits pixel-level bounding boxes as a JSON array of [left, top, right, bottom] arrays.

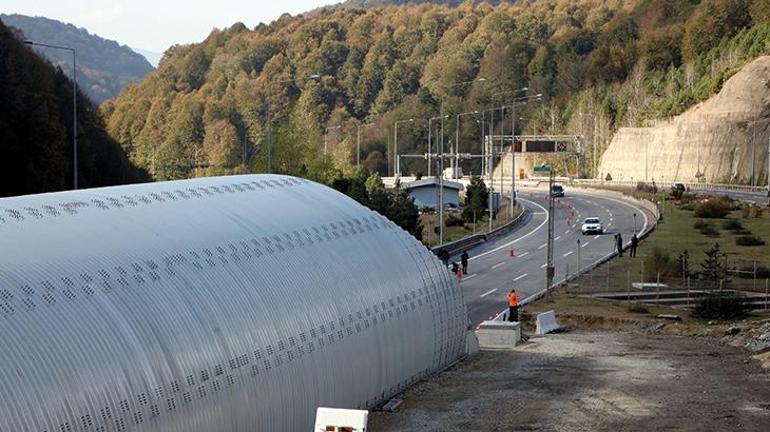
[[0, 175, 467, 432]]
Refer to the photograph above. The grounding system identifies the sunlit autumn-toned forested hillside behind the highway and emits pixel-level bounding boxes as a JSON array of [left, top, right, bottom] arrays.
[[102, 0, 770, 183]]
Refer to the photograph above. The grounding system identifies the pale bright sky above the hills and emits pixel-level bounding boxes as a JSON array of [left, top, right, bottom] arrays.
[[0, 0, 334, 53]]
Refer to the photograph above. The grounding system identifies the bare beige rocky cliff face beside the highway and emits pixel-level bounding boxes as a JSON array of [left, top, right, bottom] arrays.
[[600, 56, 770, 184]]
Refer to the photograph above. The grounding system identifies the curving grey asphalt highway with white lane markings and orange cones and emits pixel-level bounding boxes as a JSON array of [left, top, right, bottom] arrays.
[[452, 189, 653, 325]]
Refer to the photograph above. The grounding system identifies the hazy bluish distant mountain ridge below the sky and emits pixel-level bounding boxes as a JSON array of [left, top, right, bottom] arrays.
[[0, 14, 155, 104]]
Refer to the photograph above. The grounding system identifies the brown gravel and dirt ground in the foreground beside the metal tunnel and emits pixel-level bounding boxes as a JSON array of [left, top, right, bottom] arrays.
[[369, 331, 770, 431]]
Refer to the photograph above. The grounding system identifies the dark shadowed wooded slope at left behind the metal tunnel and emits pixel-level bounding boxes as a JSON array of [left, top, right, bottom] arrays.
[[0, 23, 147, 196]]
